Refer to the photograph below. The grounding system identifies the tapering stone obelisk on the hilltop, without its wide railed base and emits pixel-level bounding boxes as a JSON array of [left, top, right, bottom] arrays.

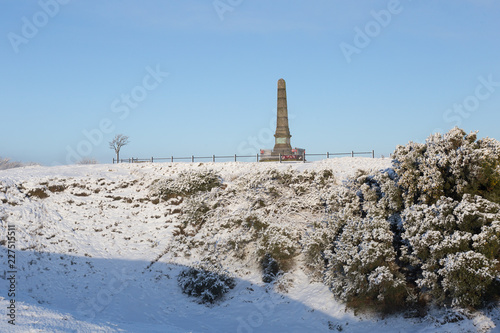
[[273, 79, 292, 155]]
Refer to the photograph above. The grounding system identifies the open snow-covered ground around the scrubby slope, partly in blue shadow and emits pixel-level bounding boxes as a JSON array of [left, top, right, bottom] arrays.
[[0, 157, 500, 332]]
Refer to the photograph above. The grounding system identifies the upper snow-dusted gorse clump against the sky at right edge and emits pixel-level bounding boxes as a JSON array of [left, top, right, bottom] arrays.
[[393, 127, 500, 206]]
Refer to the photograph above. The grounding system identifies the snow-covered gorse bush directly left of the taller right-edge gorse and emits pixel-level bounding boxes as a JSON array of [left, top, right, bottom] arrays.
[[306, 170, 412, 308]]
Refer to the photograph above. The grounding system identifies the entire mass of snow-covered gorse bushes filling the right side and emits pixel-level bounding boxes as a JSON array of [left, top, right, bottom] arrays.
[[305, 128, 500, 307]]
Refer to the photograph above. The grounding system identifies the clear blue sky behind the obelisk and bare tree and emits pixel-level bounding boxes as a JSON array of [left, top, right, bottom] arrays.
[[0, 0, 500, 165]]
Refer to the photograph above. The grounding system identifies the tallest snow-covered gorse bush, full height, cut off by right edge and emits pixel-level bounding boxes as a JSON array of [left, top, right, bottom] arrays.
[[394, 128, 500, 307]]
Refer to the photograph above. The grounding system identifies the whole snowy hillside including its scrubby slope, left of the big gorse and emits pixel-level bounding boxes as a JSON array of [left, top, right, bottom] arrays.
[[0, 158, 500, 332]]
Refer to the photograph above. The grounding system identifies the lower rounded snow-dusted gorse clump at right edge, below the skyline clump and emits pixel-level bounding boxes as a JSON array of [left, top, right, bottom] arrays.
[[402, 194, 500, 306]]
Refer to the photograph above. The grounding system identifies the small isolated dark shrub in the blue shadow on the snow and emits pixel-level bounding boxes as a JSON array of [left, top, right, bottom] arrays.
[[177, 262, 236, 303]]
